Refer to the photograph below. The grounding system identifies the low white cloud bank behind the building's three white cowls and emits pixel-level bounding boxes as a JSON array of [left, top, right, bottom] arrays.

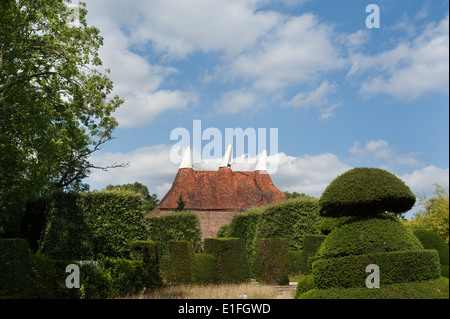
[[86, 145, 351, 198]]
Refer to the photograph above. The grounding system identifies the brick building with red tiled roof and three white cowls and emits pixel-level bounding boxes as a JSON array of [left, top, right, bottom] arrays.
[[147, 147, 285, 238]]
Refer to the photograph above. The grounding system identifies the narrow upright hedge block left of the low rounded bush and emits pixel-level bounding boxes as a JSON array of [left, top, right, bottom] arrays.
[[169, 240, 195, 284]]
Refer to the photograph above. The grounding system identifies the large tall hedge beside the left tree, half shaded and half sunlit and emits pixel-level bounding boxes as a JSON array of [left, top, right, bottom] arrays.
[[39, 191, 147, 260]]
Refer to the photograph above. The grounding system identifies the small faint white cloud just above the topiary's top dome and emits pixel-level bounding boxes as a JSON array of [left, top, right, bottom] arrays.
[[349, 140, 420, 170]]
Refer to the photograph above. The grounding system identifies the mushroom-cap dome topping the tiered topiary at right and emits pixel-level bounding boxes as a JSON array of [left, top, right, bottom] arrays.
[[319, 167, 416, 217]]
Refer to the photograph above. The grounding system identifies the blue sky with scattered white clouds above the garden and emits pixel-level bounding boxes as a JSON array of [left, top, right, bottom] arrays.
[[79, 0, 449, 217]]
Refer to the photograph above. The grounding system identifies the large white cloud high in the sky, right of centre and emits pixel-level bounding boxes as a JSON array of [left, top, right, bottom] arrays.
[[225, 14, 344, 92]]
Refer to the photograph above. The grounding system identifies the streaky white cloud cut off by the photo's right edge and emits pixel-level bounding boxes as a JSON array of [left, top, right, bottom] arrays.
[[347, 15, 449, 101]]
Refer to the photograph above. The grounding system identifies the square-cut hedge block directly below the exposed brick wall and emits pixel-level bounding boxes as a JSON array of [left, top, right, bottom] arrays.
[[204, 238, 250, 283]]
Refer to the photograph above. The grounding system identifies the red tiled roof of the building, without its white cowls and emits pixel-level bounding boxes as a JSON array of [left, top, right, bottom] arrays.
[[149, 168, 285, 214]]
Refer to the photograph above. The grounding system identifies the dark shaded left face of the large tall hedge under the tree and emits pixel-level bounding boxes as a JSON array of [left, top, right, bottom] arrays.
[[39, 192, 94, 260]]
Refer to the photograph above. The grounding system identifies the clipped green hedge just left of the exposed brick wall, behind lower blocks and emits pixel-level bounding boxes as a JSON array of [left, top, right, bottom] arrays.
[[144, 211, 201, 255]]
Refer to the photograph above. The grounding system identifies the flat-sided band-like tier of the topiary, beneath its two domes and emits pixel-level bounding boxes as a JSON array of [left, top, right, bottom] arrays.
[[312, 249, 441, 289]]
